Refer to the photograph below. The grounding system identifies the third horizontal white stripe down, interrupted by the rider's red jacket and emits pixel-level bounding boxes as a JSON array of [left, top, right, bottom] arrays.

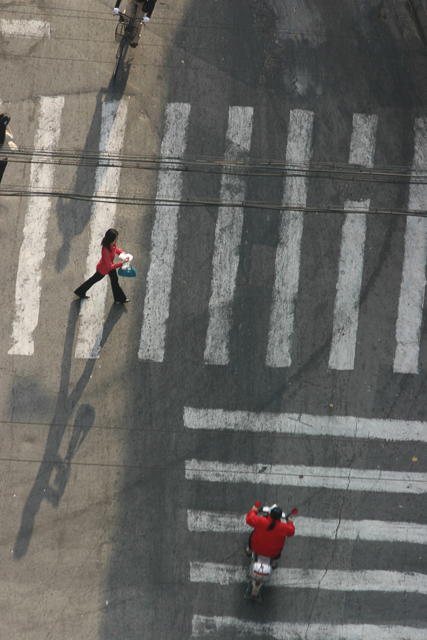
[[187, 509, 427, 544]]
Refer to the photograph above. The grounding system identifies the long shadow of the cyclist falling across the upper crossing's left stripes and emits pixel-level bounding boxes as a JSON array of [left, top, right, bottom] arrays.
[[55, 63, 130, 272]]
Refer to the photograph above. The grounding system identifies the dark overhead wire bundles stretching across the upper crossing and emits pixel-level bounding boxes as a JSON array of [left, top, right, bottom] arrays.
[[0, 148, 427, 217]]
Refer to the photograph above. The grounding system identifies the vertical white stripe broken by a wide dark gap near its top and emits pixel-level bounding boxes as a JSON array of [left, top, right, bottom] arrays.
[[329, 113, 378, 371]]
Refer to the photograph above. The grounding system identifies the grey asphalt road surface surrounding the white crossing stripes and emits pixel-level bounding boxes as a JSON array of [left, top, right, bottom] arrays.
[[0, 0, 427, 640]]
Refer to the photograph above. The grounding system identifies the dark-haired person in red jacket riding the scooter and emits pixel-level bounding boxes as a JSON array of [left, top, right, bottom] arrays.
[[246, 506, 295, 568]]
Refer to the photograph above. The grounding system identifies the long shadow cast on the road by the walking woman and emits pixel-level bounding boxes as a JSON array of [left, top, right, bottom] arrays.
[[13, 300, 125, 560]]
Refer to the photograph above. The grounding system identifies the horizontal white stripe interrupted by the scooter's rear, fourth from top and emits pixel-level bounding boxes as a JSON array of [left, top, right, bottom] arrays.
[[190, 562, 427, 595]]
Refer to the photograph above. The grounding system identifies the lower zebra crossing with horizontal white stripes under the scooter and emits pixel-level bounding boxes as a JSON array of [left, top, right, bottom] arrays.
[[183, 407, 427, 640]]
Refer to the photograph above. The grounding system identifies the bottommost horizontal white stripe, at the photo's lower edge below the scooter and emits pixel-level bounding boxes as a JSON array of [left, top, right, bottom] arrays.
[[191, 615, 427, 640]]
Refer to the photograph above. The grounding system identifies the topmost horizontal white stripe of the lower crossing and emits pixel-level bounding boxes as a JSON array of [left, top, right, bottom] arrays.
[[184, 407, 427, 442]]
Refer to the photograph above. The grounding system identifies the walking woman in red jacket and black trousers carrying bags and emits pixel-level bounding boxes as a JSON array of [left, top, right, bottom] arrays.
[[74, 229, 130, 304]]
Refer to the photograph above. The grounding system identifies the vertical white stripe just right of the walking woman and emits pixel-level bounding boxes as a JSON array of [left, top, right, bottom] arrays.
[[138, 102, 190, 362]]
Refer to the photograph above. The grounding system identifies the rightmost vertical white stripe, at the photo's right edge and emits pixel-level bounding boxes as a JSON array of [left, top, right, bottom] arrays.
[[393, 118, 427, 373]]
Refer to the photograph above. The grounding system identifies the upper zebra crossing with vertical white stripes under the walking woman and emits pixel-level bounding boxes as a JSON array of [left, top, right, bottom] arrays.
[[8, 96, 427, 374]]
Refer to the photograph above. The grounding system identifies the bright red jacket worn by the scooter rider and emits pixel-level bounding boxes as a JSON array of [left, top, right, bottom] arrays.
[[246, 509, 295, 558]]
